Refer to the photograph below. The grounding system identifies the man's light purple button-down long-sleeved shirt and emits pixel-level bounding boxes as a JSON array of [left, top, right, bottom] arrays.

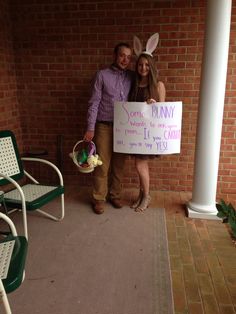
[[87, 65, 133, 131]]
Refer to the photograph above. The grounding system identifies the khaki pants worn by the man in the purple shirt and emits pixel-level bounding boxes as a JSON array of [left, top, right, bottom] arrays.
[[93, 122, 125, 201]]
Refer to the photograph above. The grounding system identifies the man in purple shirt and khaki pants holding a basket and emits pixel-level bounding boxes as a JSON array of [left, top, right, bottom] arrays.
[[84, 43, 133, 214]]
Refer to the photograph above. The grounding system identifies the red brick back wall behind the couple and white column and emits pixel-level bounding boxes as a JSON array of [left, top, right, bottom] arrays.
[[0, 0, 236, 204]]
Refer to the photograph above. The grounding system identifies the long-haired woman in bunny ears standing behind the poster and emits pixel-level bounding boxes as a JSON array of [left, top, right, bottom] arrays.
[[130, 52, 166, 212]]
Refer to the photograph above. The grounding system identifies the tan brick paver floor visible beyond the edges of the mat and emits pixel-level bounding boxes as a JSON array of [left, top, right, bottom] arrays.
[[2, 186, 236, 314]]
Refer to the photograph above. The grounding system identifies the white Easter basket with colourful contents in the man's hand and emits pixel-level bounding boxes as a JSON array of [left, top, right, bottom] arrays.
[[70, 140, 102, 173]]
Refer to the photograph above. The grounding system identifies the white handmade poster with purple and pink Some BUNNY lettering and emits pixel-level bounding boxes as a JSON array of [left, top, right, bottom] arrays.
[[114, 101, 182, 155]]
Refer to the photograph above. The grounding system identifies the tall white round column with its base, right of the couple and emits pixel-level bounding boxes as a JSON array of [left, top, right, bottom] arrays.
[[187, 0, 232, 219]]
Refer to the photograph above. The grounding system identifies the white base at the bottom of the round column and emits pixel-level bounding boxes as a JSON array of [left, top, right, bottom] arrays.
[[186, 202, 221, 220]]
